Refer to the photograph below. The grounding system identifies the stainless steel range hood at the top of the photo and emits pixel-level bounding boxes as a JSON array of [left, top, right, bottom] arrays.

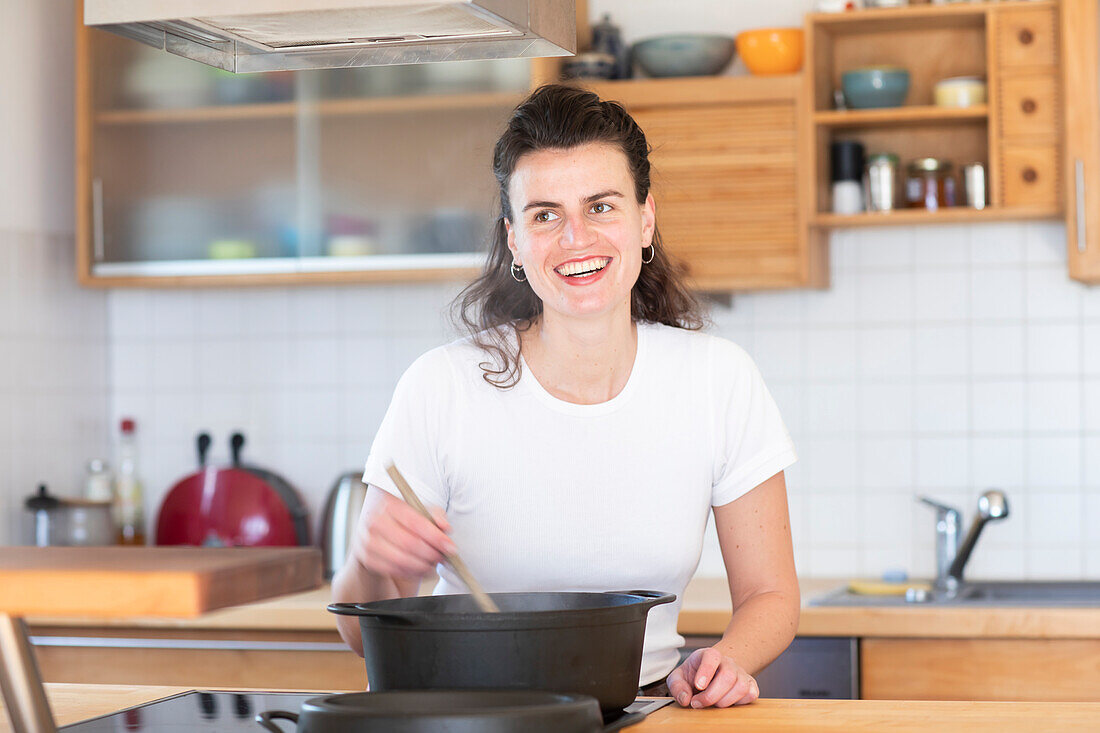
[[84, 0, 576, 72]]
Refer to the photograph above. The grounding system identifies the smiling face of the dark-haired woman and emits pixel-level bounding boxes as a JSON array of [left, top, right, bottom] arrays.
[[506, 143, 655, 318]]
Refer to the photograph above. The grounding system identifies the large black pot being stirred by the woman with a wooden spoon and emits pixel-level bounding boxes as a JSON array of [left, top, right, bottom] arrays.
[[329, 590, 677, 718]]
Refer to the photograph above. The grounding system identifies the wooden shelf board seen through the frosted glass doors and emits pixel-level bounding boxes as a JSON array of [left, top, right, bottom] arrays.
[[96, 91, 524, 125]]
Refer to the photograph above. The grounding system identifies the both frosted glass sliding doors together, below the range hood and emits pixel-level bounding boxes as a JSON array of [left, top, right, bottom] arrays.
[[87, 24, 530, 276]]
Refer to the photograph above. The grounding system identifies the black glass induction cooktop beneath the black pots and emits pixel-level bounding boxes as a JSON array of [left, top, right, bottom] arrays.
[[61, 691, 672, 733]]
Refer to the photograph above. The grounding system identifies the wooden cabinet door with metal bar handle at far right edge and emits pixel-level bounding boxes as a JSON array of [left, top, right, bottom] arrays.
[[1059, 0, 1100, 284]]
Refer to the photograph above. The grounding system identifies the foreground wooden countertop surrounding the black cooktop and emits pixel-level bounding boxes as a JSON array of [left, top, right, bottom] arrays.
[[0, 685, 1100, 733]]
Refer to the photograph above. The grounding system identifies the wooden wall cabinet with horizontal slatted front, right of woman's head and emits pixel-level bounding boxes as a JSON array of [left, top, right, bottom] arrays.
[[592, 75, 827, 291]]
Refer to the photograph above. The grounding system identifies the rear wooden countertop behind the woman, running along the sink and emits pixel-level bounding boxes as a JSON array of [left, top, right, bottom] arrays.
[[28, 578, 1100, 638]]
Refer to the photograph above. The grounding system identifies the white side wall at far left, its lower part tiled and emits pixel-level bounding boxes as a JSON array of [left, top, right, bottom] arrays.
[[0, 0, 107, 544]]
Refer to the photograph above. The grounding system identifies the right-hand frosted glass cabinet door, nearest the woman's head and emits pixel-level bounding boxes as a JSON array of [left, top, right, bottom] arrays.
[[301, 62, 528, 267]]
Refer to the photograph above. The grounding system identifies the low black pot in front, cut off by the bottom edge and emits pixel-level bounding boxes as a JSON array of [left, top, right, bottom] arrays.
[[256, 690, 645, 733]]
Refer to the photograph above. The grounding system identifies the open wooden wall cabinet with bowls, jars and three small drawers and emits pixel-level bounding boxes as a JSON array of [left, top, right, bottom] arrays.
[[803, 0, 1064, 229]]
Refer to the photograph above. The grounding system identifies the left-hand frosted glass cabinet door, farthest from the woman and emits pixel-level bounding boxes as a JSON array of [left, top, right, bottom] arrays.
[[91, 31, 298, 274]]
